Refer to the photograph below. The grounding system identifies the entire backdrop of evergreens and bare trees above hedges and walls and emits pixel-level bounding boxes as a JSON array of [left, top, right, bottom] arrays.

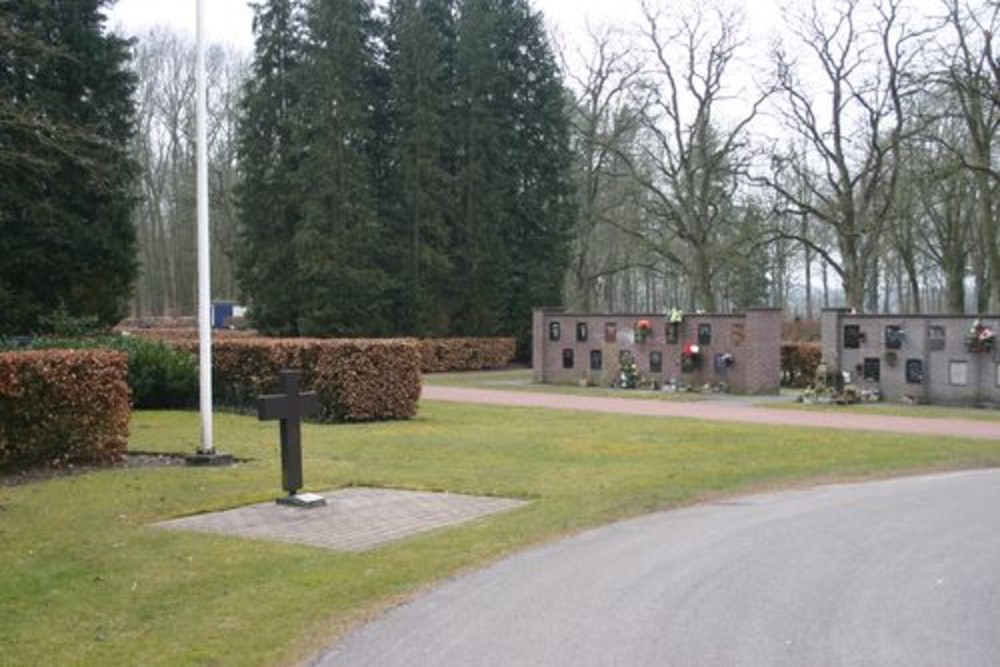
[[0, 0, 1000, 340]]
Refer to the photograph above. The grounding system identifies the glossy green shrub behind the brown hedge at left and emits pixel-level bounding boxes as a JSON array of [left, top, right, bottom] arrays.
[[15, 336, 198, 410]]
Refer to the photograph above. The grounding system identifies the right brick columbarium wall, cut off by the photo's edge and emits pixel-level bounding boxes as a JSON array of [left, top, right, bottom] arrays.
[[822, 309, 1000, 407]]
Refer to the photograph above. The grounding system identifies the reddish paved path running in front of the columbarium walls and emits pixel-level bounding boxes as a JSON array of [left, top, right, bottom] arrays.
[[422, 385, 1000, 440]]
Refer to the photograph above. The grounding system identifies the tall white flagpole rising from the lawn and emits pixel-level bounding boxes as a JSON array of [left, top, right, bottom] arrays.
[[197, 0, 215, 455]]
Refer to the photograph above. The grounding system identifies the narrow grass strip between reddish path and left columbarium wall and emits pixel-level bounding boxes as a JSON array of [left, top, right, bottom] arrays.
[[423, 368, 705, 401]]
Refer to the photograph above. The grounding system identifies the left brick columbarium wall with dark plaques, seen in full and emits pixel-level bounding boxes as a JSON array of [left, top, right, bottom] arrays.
[[532, 308, 782, 394]]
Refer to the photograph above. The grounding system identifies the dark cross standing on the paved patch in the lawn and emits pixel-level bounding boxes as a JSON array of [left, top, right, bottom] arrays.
[[257, 370, 326, 507]]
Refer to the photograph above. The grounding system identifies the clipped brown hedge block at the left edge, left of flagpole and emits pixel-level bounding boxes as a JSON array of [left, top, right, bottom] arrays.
[[0, 350, 131, 469]]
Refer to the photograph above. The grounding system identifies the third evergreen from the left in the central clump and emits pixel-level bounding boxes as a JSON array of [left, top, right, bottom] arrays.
[[384, 0, 457, 336]]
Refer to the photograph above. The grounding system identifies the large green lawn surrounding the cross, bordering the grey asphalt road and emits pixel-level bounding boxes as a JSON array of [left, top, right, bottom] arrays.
[[0, 402, 1000, 665]]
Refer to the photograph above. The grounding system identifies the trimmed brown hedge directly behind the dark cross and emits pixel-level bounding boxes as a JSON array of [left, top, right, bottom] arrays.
[[179, 338, 420, 421]]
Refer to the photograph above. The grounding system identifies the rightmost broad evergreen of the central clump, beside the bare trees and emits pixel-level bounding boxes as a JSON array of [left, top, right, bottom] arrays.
[[454, 0, 574, 347]]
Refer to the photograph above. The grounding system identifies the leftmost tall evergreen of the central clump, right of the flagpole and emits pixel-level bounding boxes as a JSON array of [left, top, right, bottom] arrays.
[[236, 0, 304, 334]]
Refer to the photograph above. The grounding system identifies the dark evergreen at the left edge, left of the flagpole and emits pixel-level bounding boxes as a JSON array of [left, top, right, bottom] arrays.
[[0, 0, 136, 332]]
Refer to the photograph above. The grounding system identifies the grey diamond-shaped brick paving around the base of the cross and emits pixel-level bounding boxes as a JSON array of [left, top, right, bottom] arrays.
[[155, 487, 526, 551]]
